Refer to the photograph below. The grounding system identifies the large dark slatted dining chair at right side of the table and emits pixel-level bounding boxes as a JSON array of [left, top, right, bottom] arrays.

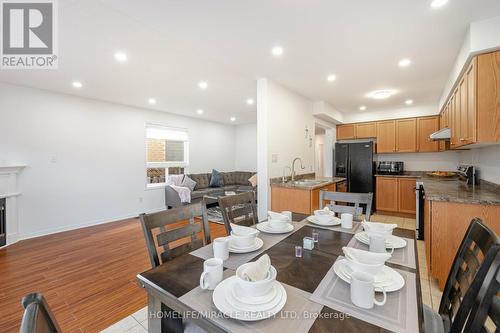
[[424, 218, 500, 332]]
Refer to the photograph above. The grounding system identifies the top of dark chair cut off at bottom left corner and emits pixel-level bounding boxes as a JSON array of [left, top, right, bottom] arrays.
[[19, 293, 61, 333]]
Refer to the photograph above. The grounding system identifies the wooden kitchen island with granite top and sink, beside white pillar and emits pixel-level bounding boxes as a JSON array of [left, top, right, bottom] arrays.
[[271, 175, 346, 215]]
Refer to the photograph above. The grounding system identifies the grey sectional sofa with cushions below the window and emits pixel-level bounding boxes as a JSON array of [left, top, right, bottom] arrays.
[[165, 171, 257, 208]]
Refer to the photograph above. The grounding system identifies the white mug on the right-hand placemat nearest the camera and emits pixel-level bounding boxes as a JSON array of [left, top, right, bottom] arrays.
[[351, 272, 387, 309]]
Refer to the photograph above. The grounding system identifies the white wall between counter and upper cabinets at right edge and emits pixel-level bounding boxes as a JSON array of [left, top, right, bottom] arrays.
[[460, 145, 500, 185]]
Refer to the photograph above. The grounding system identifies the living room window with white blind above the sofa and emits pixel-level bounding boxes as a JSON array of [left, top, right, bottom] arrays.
[[146, 125, 189, 187]]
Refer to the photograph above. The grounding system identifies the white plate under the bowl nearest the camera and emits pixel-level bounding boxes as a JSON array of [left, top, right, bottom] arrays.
[[212, 276, 287, 321]]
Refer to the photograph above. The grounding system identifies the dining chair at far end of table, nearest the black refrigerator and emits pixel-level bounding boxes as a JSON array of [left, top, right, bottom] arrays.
[[319, 191, 373, 221]]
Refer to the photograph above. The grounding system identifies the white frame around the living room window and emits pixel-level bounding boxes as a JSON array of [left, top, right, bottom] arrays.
[[144, 123, 189, 189]]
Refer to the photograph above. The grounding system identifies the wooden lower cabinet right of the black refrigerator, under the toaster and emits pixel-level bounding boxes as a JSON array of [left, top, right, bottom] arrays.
[[375, 176, 417, 216]]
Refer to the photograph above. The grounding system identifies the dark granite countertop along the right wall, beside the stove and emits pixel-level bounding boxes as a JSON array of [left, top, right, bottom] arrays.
[[375, 171, 500, 205]]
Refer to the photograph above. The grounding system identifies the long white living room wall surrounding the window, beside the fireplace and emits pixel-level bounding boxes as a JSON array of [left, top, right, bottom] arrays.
[[0, 84, 235, 238]]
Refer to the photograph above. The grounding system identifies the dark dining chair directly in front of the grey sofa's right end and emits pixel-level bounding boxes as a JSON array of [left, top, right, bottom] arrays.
[[219, 191, 257, 235]]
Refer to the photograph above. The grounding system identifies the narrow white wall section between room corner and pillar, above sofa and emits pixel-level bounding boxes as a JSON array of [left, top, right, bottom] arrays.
[[234, 123, 257, 171]]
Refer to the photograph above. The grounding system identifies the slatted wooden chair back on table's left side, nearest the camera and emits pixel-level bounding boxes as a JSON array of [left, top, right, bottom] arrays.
[[139, 203, 210, 268]]
